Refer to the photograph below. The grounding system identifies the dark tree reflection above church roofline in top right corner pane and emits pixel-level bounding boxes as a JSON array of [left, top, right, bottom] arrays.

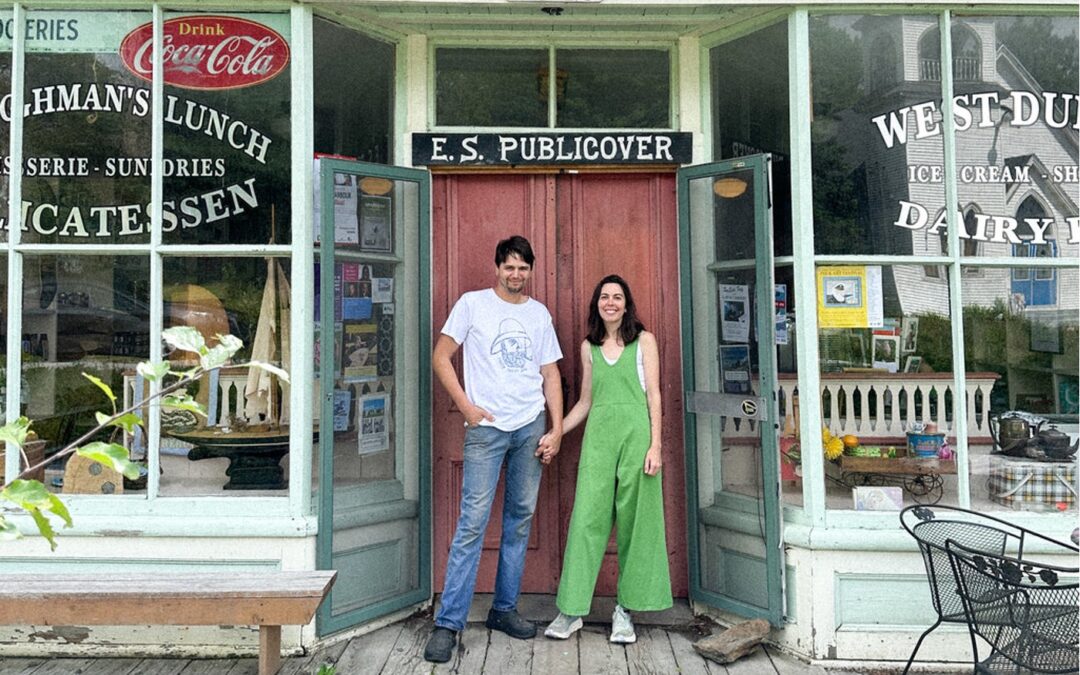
[[997, 16, 1080, 92]]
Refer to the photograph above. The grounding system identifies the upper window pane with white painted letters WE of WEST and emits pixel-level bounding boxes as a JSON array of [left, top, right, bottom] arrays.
[[810, 15, 945, 255]]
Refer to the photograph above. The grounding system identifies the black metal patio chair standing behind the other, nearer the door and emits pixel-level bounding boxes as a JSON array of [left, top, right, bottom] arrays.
[[900, 504, 1067, 674]]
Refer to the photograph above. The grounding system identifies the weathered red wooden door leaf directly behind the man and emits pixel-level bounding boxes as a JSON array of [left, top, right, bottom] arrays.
[[431, 174, 565, 593]]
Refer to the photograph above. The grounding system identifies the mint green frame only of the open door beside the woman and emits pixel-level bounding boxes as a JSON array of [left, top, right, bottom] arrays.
[[678, 154, 784, 626]]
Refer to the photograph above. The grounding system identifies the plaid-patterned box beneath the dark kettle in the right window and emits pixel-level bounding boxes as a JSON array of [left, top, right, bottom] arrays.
[[988, 455, 1077, 511]]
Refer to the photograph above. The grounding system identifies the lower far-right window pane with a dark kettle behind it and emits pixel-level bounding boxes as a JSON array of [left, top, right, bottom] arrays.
[[962, 267, 1080, 513]]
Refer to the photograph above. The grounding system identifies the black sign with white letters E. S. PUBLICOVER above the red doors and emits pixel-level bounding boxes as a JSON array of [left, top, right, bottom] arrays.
[[413, 132, 692, 166]]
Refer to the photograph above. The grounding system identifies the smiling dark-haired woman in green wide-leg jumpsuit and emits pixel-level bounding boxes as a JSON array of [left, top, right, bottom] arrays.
[[541, 274, 672, 644]]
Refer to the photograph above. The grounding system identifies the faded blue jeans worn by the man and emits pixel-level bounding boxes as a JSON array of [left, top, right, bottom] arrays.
[[435, 413, 544, 631]]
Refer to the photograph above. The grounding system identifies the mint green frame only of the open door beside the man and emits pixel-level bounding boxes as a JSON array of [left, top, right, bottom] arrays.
[[315, 159, 431, 636]]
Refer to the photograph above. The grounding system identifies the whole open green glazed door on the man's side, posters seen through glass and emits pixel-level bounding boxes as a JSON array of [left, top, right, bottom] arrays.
[[313, 159, 431, 636]]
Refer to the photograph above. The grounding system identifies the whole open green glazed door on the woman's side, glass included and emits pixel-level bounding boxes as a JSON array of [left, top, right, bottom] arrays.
[[678, 154, 784, 625]]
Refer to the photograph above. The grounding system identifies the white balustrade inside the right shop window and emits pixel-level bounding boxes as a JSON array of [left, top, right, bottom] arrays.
[[725, 373, 999, 440]]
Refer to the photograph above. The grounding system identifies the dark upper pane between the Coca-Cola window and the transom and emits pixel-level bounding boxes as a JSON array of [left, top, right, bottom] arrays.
[[314, 17, 394, 164]]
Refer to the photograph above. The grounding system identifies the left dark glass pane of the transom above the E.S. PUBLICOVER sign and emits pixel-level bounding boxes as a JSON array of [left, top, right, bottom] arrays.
[[435, 48, 549, 126]]
